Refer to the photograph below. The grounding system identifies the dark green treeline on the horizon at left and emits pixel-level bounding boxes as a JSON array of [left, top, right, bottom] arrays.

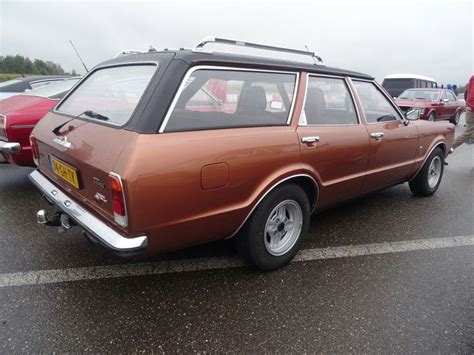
[[0, 55, 76, 75]]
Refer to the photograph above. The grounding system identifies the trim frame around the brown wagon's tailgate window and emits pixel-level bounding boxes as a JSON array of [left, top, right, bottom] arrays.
[[53, 61, 160, 127]]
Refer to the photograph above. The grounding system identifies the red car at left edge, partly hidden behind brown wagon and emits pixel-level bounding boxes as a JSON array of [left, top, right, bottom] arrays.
[[0, 78, 79, 166]]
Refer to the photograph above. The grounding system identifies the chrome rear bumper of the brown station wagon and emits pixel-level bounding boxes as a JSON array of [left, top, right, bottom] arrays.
[[29, 170, 148, 254]]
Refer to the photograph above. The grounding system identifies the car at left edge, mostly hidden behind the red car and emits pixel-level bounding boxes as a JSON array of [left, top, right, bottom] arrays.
[[0, 75, 71, 100]]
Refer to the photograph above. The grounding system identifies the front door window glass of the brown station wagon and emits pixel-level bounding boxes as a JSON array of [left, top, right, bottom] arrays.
[[354, 81, 400, 123]]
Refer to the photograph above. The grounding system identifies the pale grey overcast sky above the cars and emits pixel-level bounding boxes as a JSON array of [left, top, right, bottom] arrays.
[[0, 0, 474, 84]]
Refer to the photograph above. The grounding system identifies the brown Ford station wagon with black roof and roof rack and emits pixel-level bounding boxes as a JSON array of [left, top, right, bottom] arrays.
[[30, 38, 454, 270]]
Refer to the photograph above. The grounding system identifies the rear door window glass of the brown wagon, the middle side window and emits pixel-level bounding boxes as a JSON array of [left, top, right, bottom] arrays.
[[300, 76, 358, 125]]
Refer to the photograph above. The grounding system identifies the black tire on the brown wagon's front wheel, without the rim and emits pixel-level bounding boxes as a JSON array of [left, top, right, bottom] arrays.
[[408, 147, 444, 196]]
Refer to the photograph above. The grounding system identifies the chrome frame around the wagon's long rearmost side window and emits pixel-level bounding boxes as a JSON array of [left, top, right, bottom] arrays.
[[158, 65, 300, 133]]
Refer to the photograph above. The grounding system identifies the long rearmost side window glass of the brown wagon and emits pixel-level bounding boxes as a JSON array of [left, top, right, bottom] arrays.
[[160, 69, 297, 132]]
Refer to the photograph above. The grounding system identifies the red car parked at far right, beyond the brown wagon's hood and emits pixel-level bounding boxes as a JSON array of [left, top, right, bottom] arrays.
[[395, 88, 466, 125]]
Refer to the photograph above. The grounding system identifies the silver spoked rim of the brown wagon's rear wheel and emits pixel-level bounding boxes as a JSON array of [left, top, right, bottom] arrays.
[[264, 200, 303, 256]]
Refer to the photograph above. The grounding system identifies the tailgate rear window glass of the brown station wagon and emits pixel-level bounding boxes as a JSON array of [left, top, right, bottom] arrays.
[[57, 65, 156, 126]]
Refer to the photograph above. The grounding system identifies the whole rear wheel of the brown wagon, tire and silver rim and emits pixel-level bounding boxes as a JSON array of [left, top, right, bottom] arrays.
[[236, 184, 310, 270]]
